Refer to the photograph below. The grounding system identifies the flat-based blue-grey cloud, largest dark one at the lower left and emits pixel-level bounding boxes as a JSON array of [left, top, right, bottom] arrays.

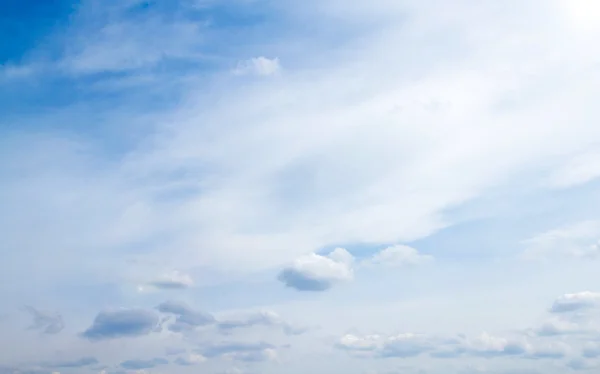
[[81, 309, 159, 340]]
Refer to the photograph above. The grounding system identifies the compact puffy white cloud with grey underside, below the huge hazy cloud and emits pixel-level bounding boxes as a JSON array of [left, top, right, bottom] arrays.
[[278, 248, 353, 291]]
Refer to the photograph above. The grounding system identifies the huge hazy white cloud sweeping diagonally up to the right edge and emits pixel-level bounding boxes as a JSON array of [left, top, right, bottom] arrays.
[[111, 2, 600, 274]]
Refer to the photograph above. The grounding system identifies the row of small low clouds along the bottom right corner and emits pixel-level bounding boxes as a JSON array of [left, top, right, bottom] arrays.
[[335, 292, 600, 370]]
